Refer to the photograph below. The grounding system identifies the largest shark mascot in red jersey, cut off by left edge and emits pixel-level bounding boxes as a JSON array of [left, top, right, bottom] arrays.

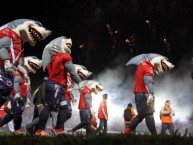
[[0, 19, 51, 106]]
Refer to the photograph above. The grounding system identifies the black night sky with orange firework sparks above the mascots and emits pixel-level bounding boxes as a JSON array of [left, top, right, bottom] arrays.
[[0, 0, 193, 90]]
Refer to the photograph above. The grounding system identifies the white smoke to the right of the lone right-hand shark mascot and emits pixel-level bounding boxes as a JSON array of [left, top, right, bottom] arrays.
[[155, 58, 193, 123]]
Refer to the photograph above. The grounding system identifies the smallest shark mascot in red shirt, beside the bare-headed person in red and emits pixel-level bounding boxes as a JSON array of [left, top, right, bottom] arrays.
[[67, 80, 104, 135]]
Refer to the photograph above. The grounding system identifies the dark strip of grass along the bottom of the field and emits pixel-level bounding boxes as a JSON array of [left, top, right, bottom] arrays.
[[0, 133, 193, 145]]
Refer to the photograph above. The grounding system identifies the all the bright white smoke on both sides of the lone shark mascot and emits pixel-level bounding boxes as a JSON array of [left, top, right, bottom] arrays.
[[90, 51, 193, 131]]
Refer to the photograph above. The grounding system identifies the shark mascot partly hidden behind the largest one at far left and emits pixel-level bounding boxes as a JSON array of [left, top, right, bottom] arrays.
[[0, 56, 42, 133]]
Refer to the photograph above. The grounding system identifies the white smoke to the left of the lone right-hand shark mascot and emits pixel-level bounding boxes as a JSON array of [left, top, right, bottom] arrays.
[[93, 53, 134, 131]]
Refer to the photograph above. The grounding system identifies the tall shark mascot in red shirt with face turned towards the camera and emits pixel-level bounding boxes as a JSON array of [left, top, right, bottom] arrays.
[[36, 36, 82, 135]]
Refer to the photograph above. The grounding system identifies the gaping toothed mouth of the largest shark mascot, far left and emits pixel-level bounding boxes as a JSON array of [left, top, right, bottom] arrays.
[[29, 26, 43, 42]]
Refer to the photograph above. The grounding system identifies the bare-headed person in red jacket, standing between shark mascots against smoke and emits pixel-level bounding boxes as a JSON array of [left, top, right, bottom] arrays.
[[95, 94, 108, 134]]
